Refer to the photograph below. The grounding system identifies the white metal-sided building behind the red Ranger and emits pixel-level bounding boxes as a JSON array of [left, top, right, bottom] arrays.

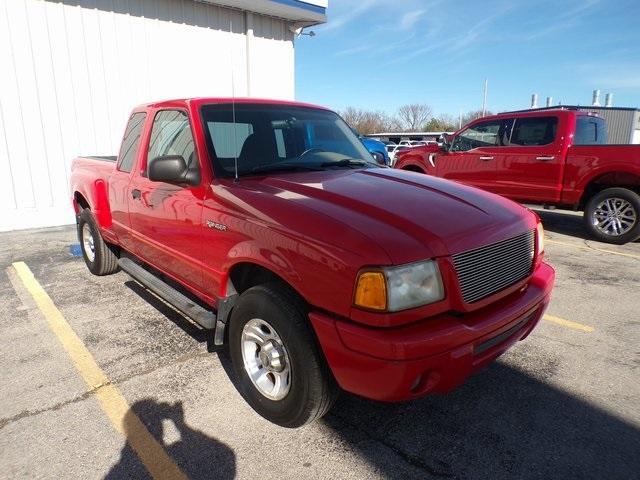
[[0, 0, 327, 231]]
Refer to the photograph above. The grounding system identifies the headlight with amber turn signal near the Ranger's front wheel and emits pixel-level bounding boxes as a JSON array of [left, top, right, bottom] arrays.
[[354, 260, 444, 312]]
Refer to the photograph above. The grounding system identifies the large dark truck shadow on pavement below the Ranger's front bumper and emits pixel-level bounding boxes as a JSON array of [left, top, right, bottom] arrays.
[[323, 363, 640, 480]]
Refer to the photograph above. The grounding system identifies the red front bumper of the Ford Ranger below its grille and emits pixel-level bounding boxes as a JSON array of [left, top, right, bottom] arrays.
[[310, 263, 555, 402]]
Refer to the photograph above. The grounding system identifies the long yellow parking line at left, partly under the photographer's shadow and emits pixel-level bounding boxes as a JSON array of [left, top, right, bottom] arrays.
[[13, 262, 187, 480]]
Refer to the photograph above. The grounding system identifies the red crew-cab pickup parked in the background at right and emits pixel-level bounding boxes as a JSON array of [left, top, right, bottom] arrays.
[[394, 108, 640, 244]]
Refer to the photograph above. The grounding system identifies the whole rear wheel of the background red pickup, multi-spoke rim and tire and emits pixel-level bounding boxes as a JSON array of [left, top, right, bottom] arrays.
[[584, 188, 640, 244]]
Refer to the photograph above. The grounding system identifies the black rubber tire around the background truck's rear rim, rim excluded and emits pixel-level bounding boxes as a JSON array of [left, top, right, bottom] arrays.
[[583, 188, 640, 245]]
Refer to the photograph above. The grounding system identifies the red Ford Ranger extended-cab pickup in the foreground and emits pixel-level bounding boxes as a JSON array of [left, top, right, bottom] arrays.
[[71, 98, 554, 427]]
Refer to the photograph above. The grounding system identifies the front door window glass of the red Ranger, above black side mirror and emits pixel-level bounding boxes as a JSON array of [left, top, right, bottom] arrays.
[[147, 110, 198, 169]]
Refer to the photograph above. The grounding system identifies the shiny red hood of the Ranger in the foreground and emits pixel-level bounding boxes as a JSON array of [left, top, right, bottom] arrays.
[[220, 168, 536, 264]]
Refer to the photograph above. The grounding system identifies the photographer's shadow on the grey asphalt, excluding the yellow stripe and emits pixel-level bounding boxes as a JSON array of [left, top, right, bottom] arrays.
[[105, 398, 236, 480]]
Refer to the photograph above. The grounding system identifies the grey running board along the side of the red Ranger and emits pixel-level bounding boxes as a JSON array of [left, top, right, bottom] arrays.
[[118, 258, 218, 330]]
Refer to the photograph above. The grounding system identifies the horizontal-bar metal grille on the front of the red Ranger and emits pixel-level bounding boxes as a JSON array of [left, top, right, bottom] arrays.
[[452, 230, 534, 303]]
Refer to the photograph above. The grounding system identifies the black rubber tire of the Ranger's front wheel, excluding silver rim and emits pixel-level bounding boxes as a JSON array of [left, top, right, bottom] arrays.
[[229, 283, 338, 428]]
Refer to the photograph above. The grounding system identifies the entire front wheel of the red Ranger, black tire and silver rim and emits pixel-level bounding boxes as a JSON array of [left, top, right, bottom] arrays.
[[229, 283, 338, 428]]
